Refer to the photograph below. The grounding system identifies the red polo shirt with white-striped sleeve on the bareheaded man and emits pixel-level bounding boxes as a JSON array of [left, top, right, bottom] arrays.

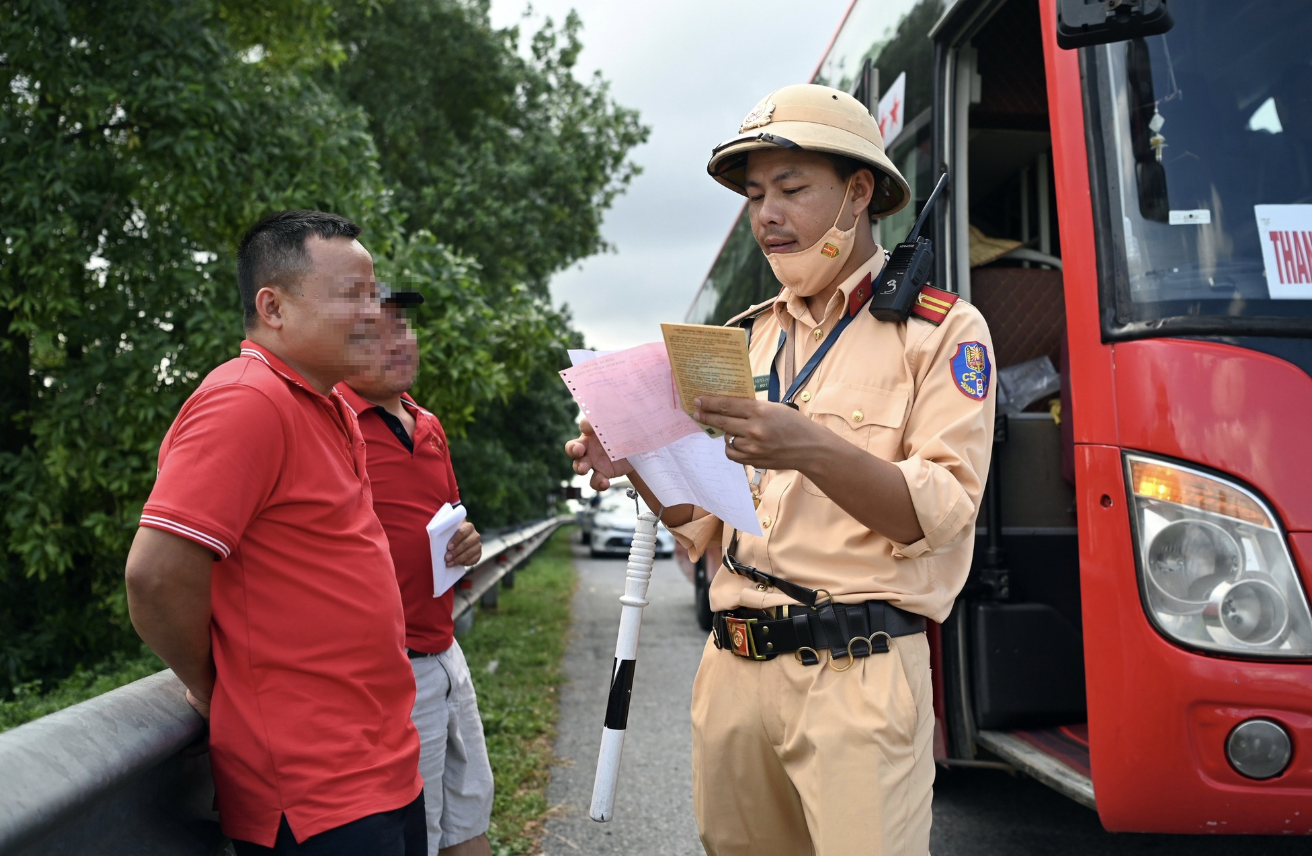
[[142, 341, 422, 847]]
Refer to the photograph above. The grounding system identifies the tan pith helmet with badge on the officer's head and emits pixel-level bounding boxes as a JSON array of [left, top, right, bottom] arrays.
[[706, 83, 911, 217]]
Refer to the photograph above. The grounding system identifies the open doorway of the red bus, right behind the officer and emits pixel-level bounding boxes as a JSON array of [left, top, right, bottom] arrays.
[[933, 0, 1094, 807]]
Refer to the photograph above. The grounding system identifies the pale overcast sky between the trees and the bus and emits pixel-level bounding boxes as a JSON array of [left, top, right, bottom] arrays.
[[492, 0, 849, 349]]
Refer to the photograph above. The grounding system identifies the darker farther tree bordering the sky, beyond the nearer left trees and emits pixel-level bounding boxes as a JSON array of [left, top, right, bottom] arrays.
[[321, 0, 647, 526]]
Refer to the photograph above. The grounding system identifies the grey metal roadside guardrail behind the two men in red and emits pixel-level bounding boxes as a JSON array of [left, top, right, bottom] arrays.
[[0, 515, 573, 856]]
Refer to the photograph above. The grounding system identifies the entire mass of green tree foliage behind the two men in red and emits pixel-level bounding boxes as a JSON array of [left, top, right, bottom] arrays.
[[0, 0, 643, 691]]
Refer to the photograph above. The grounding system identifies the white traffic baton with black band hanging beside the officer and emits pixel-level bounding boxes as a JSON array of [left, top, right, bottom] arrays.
[[588, 512, 659, 823]]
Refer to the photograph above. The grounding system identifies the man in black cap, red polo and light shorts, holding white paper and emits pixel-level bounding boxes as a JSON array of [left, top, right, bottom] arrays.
[[337, 291, 492, 856]]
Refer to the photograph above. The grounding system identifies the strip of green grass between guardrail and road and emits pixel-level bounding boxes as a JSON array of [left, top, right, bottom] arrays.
[[461, 529, 575, 856]]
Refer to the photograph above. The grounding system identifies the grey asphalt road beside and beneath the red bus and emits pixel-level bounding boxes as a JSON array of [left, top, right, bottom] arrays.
[[543, 536, 1312, 856]]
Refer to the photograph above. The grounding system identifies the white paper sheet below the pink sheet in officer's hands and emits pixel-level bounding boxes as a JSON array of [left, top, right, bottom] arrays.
[[562, 351, 761, 536]]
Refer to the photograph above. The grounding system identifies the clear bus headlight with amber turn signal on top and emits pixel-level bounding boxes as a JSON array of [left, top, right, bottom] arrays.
[[1126, 454, 1312, 658]]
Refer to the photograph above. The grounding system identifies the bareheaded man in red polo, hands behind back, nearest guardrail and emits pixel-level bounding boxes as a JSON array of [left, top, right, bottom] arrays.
[[127, 211, 426, 856]]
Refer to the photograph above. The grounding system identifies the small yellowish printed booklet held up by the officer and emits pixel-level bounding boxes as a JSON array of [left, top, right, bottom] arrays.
[[660, 324, 756, 437]]
